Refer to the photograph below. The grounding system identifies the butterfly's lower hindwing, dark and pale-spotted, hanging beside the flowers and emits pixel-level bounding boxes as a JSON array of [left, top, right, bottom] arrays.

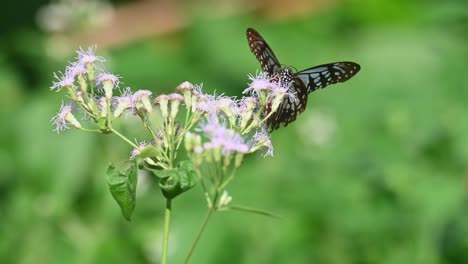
[[266, 76, 308, 130]]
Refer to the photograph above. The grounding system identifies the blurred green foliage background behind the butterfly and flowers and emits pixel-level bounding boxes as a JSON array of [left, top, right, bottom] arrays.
[[0, 0, 468, 264]]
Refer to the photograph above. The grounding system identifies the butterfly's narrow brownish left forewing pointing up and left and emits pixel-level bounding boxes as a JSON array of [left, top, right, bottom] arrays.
[[247, 28, 281, 75]]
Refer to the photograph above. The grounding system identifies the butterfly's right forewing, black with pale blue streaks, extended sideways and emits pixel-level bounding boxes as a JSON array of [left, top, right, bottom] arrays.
[[296, 61, 361, 94]]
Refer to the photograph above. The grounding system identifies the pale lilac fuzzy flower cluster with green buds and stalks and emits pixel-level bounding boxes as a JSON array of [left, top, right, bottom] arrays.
[[51, 47, 294, 210]]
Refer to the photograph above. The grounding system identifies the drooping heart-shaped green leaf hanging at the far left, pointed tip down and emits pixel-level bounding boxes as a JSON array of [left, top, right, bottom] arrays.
[[106, 163, 138, 221]]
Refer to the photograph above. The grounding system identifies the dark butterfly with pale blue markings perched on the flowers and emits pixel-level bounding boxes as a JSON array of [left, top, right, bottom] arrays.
[[247, 28, 361, 130]]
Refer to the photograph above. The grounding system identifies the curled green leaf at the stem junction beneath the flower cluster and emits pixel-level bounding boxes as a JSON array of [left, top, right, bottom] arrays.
[[154, 161, 198, 199]]
